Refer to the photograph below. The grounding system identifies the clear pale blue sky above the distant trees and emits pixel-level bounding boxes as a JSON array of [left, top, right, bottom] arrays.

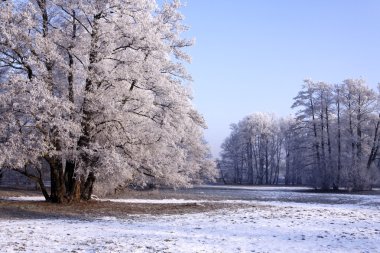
[[182, 0, 380, 157]]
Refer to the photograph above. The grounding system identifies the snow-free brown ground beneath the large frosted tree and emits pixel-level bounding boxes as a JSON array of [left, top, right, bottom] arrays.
[[0, 188, 233, 219]]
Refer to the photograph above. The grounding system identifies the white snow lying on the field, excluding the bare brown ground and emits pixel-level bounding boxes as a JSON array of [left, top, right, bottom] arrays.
[[0, 186, 380, 252]]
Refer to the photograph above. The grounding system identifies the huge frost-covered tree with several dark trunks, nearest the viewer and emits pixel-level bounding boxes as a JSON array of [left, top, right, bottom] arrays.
[[0, 0, 215, 202]]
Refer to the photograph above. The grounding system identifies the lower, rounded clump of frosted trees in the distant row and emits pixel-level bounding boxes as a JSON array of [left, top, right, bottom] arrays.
[[219, 113, 283, 184]]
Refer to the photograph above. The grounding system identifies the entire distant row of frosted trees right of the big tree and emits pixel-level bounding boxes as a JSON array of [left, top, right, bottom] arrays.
[[219, 79, 380, 190]]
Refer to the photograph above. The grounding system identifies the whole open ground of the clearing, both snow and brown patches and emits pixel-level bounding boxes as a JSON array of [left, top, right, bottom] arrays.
[[0, 187, 380, 252]]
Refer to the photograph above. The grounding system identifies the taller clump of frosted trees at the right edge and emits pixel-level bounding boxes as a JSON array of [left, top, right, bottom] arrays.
[[293, 79, 378, 190]]
